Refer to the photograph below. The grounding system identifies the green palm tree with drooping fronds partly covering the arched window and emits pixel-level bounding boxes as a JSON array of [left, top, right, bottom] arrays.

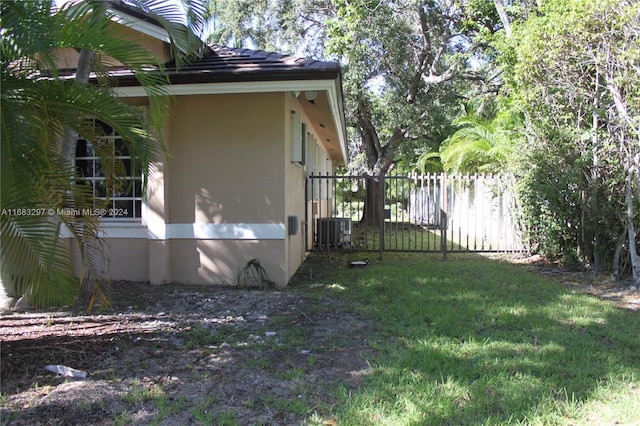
[[0, 0, 205, 307]]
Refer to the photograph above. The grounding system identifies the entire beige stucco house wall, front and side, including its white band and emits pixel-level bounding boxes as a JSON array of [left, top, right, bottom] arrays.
[[70, 92, 340, 286]]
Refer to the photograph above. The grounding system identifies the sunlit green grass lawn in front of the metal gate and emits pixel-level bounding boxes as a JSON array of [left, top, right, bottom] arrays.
[[298, 253, 640, 426]]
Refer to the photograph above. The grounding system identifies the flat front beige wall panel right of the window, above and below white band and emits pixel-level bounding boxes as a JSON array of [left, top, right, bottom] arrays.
[[165, 93, 288, 285]]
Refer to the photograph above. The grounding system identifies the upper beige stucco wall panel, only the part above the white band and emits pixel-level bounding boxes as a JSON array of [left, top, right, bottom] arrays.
[[168, 93, 285, 223]]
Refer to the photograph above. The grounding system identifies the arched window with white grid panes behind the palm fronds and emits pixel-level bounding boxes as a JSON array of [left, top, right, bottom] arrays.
[[76, 121, 142, 219]]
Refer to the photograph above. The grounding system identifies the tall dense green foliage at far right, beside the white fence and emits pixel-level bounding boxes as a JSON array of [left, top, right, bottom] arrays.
[[501, 0, 640, 271]]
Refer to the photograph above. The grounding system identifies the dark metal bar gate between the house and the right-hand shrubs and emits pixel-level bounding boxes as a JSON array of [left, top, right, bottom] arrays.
[[305, 174, 526, 254]]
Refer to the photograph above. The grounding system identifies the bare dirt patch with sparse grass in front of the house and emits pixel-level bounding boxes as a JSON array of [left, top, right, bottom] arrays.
[[0, 283, 374, 425]]
